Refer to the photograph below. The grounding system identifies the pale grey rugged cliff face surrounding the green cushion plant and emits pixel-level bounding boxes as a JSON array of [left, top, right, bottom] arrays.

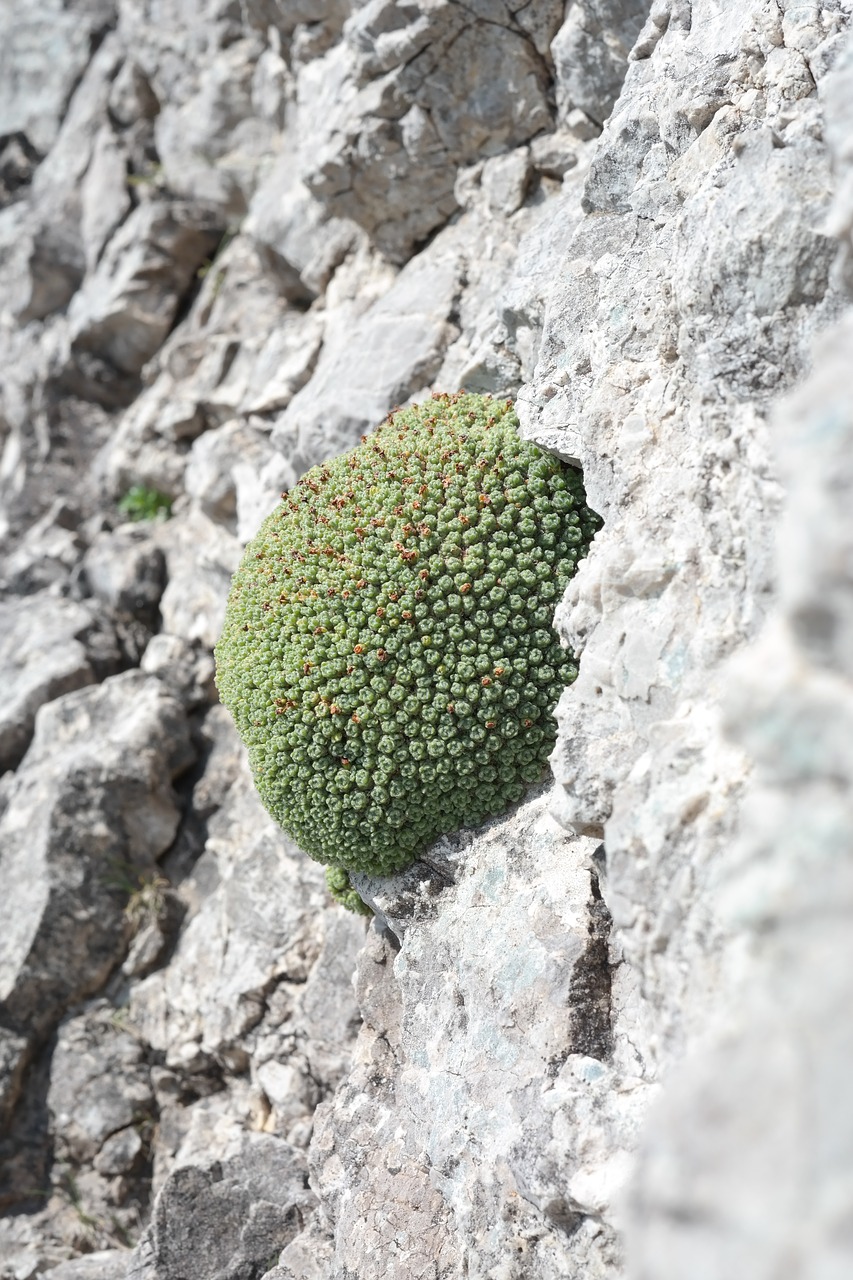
[[0, 0, 853, 1280]]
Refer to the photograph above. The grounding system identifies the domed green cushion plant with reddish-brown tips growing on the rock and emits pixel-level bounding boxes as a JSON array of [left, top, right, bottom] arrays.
[[216, 393, 601, 905]]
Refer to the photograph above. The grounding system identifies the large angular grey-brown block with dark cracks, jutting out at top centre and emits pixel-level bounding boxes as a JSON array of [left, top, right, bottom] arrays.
[[298, 3, 560, 261]]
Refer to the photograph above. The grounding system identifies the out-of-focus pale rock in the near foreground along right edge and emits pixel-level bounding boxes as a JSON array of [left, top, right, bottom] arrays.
[[629, 35, 853, 1280]]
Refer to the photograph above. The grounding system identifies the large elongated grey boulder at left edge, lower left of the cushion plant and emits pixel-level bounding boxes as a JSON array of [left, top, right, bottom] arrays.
[[0, 671, 193, 1034]]
